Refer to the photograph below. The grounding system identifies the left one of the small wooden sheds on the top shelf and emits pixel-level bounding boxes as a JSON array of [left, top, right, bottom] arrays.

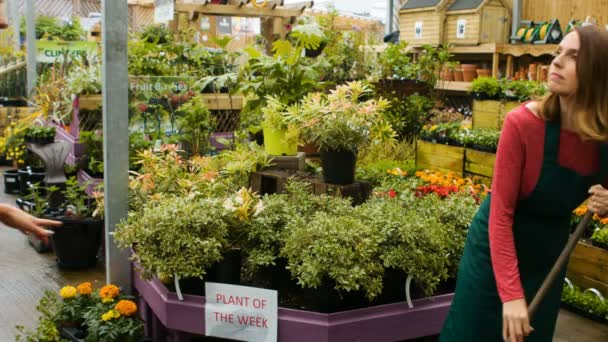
[[444, 0, 511, 45]]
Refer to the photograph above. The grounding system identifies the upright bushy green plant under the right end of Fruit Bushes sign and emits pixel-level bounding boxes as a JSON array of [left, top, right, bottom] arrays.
[[178, 96, 215, 155]]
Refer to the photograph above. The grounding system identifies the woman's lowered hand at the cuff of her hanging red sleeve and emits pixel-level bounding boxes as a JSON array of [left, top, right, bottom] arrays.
[[502, 298, 534, 342]]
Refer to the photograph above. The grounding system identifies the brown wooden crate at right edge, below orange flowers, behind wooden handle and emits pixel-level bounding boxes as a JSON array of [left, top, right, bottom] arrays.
[[567, 242, 608, 296]]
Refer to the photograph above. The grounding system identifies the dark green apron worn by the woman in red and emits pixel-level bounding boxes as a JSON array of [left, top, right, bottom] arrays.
[[439, 122, 608, 342]]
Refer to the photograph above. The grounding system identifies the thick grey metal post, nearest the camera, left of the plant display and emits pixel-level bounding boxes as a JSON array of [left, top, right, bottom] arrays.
[[102, 0, 132, 292]]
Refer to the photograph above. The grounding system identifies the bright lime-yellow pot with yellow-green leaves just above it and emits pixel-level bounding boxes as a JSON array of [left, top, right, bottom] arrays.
[[262, 96, 299, 156]]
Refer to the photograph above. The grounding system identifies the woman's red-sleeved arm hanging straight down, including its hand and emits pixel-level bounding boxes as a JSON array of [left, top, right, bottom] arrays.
[[488, 115, 532, 341]]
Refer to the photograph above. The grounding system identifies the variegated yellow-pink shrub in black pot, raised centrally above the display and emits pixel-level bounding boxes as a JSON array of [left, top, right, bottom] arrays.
[[299, 82, 388, 184]]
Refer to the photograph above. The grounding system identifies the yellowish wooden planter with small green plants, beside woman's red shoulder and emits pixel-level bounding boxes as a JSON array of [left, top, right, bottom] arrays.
[[416, 122, 500, 179]]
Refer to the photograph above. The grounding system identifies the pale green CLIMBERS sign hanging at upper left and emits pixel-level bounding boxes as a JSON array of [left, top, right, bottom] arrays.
[[36, 40, 97, 63]]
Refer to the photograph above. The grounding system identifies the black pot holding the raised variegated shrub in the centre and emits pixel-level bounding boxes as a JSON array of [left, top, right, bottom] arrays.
[[321, 151, 357, 185]]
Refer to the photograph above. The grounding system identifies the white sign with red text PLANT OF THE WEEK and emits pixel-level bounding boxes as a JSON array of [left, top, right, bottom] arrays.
[[205, 283, 278, 342]]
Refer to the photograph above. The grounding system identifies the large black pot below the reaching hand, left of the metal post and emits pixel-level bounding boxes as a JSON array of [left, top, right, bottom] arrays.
[[49, 216, 103, 269]]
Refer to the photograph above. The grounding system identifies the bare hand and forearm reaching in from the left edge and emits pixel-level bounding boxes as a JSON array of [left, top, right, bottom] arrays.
[[2, 206, 62, 244]]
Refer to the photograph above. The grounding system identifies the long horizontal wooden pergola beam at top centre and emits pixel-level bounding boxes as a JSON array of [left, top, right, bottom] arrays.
[[175, 3, 302, 18]]
